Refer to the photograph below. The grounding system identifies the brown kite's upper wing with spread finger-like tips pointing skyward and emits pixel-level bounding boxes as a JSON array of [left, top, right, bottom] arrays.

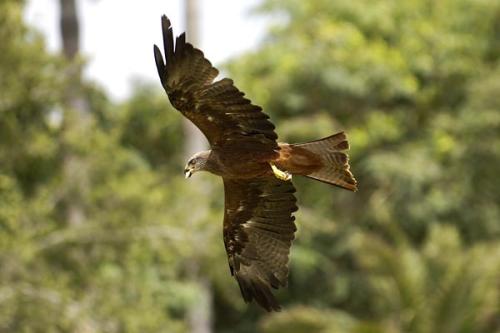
[[154, 16, 279, 154]]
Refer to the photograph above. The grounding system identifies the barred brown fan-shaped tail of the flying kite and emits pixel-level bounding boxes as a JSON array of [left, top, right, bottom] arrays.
[[291, 132, 357, 191]]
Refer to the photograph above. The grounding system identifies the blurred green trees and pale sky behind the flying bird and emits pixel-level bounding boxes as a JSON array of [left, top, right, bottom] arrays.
[[0, 0, 500, 333]]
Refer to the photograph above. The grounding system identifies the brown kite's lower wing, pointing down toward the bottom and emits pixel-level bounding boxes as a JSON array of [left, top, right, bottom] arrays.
[[224, 177, 297, 311]]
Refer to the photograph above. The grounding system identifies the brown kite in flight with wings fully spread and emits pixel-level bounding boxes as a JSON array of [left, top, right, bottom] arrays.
[[154, 16, 357, 311]]
